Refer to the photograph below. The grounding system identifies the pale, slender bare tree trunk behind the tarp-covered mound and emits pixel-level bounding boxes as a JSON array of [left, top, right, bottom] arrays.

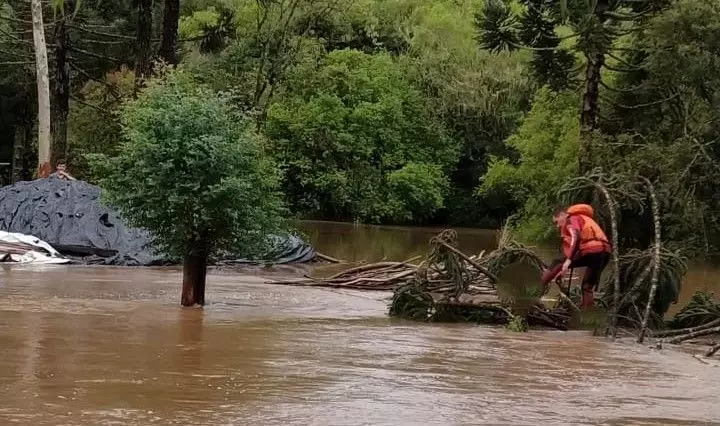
[[31, 0, 52, 177]]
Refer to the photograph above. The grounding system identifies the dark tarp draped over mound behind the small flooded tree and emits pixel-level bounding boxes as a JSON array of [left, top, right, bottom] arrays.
[[0, 177, 315, 266]]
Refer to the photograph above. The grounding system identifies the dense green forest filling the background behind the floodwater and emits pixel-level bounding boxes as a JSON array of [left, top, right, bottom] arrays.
[[0, 0, 720, 253]]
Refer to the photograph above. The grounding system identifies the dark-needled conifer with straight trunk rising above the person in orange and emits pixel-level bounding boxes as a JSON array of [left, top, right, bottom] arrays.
[[478, 0, 666, 173]]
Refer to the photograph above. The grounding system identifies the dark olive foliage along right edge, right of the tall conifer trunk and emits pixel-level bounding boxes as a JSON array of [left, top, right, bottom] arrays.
[[603, 0, 720, 253]]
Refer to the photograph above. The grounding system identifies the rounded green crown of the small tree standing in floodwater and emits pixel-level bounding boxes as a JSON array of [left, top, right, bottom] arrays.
[[95, 71, 282, 258]]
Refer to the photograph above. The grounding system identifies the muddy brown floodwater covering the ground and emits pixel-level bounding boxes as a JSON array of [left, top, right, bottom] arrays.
[[0, 223, 720, 425]]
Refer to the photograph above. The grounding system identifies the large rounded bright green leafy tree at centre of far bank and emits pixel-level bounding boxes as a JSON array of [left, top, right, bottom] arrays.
[[266, 50, 457, 222]]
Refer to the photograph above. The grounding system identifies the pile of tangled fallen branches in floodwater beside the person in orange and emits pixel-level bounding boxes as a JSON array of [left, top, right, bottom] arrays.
[[273, 230, 570, 329]]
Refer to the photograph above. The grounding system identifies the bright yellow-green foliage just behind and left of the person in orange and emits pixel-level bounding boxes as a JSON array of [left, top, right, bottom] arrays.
[[479, 88, 580, 240]]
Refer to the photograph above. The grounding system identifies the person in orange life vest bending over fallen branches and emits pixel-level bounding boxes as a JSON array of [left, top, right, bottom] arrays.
[[542, 204, 612, 309]]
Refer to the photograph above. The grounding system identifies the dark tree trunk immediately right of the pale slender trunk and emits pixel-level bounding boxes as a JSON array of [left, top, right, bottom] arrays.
[[50, 0, 74, 168]]
